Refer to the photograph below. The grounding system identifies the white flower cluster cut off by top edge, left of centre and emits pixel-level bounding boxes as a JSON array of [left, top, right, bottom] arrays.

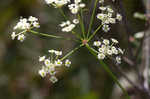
[[45, 0, 70, 8]]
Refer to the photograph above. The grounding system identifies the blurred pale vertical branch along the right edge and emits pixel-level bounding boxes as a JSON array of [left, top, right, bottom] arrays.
[[140, 0, 150, 92]]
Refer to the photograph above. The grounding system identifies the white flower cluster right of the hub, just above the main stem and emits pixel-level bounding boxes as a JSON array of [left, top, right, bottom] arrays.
[[93, 38, 124, 64]]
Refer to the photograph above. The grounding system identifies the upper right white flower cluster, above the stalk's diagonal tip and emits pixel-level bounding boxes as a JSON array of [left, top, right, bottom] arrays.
[[97, 4, 122, 32]]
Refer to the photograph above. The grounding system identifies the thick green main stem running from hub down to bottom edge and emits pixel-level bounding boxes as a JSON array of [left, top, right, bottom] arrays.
[[86, 44, 130, 99]]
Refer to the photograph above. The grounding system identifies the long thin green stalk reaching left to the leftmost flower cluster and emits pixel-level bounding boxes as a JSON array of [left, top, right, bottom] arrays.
[[29, 30, 80, 42]]
